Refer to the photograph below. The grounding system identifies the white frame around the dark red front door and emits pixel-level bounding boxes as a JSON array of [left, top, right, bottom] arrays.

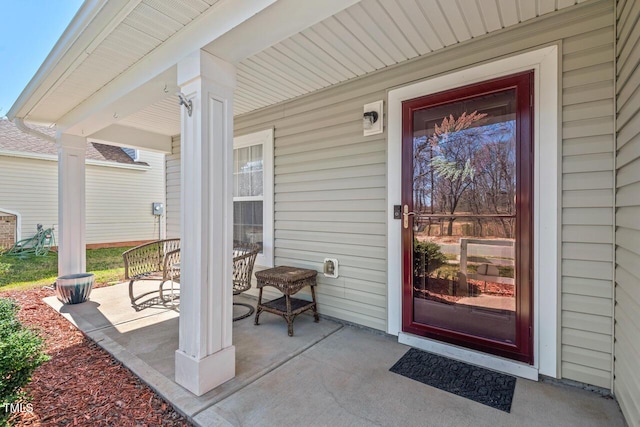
[[387, 45, 561, 380]]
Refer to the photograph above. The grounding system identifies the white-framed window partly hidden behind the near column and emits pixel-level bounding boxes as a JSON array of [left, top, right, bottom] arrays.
[[233, 129, 273, 267]]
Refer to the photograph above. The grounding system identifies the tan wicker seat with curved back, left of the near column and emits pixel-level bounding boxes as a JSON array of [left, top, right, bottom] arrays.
[[122, 239, 180, 308]]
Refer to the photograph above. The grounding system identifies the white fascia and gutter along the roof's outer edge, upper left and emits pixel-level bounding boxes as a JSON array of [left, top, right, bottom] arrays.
[[7, 0, 141, 124]]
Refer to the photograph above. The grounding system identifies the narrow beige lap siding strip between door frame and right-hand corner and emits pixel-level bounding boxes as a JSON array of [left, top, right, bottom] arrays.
[[560, 4, 614, 388]]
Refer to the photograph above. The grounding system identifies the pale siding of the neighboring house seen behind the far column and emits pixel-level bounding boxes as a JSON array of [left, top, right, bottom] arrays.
[[0, 151, 164, 244]]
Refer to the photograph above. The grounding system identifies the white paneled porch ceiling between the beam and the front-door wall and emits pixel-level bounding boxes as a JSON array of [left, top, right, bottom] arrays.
[[234, 0, 586, 115]]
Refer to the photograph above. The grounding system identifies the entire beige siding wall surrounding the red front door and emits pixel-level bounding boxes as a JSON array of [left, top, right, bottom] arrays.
[[160, 1, 620, 388]]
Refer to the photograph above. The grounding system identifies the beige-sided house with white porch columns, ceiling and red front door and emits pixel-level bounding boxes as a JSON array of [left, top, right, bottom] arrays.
[[9, 0, 640, 426]]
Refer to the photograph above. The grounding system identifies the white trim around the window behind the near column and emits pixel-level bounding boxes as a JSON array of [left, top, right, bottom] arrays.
[[233, 128, 273, 267]]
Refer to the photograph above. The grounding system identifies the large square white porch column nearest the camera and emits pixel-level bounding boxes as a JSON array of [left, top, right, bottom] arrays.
[[175, 50, 236, 396]]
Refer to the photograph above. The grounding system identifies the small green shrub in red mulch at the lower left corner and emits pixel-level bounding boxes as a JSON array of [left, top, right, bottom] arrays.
[[0, 298, 49, 424]]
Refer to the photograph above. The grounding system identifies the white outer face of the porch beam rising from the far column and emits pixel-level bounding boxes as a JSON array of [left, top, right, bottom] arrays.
[[57, 0, 276, 134]]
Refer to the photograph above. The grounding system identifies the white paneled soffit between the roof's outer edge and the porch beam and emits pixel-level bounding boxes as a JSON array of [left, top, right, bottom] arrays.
[[14, 0, 218, 127]]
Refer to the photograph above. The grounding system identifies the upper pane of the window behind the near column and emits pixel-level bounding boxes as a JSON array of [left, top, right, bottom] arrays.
[[233, 145, 263, 197]]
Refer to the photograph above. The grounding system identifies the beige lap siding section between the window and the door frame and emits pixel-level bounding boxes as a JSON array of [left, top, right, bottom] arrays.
[[235, 96, 387, 330]]
